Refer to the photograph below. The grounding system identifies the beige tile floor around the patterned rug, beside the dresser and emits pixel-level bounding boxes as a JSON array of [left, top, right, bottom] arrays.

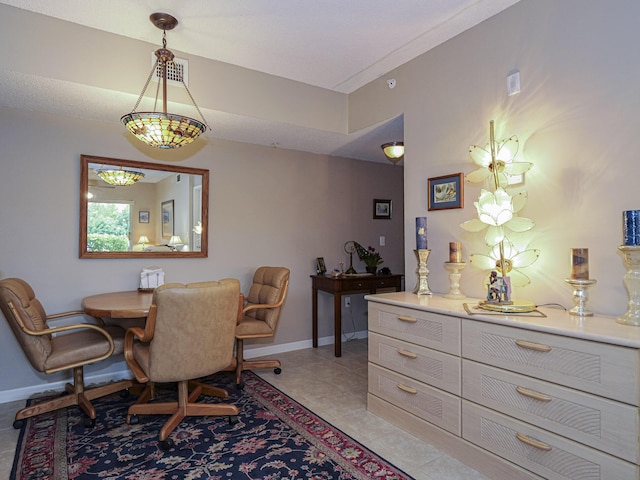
[[0, 339, 488, 480]]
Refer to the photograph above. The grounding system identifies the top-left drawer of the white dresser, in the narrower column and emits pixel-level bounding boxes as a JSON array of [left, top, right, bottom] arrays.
[[369, 302, 460, 355]]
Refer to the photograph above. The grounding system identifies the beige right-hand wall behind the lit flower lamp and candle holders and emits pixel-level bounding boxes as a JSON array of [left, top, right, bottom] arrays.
[[349, 0, 640, 315]]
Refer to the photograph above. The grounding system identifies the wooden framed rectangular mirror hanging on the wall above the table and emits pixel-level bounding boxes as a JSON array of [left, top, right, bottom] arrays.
[[80, 155, 209, 258]]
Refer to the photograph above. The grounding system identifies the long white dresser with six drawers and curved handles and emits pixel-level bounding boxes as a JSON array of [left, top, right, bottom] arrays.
[[365, 292, 640, 480]]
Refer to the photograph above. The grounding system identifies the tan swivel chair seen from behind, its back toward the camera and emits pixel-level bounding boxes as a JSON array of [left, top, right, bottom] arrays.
[[124, 279, 240, 450]]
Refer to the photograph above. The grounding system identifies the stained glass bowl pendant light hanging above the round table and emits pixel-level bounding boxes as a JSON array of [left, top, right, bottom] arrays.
[[120, 13, 207, 148]]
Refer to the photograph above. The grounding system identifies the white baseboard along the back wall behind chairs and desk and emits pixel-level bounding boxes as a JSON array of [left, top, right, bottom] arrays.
[[0, 330, 368, 403]]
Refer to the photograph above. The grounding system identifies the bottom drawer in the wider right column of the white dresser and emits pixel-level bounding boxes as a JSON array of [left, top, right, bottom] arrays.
[[462, 400, 639, 480]]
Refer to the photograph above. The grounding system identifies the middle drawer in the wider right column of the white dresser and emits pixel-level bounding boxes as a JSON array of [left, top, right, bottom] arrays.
[[462, 360, 640, 462]]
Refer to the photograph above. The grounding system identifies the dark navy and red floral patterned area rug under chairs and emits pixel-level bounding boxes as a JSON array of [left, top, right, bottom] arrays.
[[10, 372, 411, 480]]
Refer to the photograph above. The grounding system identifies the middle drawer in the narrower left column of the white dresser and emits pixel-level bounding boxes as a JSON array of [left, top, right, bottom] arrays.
[[369, 332, 460, 396]]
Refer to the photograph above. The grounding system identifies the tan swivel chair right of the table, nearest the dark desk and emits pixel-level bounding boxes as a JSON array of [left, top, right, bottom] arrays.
[[235, 267, 290, 388]]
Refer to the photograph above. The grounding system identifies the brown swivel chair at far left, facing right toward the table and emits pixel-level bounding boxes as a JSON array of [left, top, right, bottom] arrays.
[[0, 278, 133, 428]]
